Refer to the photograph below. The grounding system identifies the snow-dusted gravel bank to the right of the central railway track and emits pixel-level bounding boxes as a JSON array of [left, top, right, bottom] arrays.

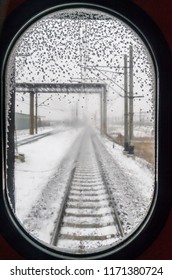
[[97, 137, 154, 234]]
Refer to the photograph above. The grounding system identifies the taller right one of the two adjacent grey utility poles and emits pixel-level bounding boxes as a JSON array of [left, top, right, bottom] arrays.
[[128, 45, 134, 154]]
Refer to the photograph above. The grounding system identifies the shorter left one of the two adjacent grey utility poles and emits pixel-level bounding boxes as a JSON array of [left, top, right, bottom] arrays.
[[124, 55, 129, 152]]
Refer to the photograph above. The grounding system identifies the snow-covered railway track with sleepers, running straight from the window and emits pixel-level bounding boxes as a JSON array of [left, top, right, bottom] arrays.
[[51, 130, 124, 254]]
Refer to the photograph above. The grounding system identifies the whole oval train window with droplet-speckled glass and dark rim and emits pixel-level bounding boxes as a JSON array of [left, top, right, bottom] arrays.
[[0, 0, 171, 258]]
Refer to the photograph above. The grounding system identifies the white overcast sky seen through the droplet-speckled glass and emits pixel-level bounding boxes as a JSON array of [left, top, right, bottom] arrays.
[[15, 9, 154, 124]]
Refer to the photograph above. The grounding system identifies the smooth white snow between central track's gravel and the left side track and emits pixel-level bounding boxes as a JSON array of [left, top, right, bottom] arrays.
[[15, 128, 83, 222]]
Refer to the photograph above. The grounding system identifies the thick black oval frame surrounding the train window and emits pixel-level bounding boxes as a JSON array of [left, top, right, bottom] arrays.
[[0, 0, 171, 259]]
